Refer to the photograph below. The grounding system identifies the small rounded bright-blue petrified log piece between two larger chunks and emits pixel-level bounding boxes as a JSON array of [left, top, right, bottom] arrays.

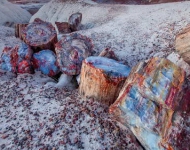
[[33, 50, 59, 76]]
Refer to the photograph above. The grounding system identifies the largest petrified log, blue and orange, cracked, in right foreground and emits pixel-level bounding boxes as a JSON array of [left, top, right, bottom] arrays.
[[110, 58, 185, 150]]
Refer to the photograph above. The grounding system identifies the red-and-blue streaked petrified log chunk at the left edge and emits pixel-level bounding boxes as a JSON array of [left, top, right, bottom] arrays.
[[0, 42, 33, 73]]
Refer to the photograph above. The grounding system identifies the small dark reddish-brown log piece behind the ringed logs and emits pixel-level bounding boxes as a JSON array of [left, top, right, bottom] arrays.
[[55, 22, 71, 34]]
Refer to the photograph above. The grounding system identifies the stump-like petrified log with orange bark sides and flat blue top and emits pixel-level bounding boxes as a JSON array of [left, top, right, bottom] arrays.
[[79, 56, 130, 105]]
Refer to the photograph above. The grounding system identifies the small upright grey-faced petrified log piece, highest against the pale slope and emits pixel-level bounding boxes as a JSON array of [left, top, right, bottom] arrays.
[[69, 13, 82, 32]]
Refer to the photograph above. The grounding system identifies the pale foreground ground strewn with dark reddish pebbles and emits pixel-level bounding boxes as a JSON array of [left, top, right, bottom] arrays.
[[0, 71, 142, 150]]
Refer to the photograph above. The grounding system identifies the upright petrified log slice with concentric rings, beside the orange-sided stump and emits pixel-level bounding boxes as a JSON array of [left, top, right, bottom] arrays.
[[55, 33, 93, 75]]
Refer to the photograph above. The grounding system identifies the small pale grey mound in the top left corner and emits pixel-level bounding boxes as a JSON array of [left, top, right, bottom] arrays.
[[0, 0, 31, 26]]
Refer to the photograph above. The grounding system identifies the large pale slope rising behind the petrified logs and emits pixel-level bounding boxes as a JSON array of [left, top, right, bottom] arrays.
[[30, 0, 190, 66]]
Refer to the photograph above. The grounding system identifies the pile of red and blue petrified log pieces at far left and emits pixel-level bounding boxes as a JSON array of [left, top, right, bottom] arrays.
[[0, 13, 84, 76]]
